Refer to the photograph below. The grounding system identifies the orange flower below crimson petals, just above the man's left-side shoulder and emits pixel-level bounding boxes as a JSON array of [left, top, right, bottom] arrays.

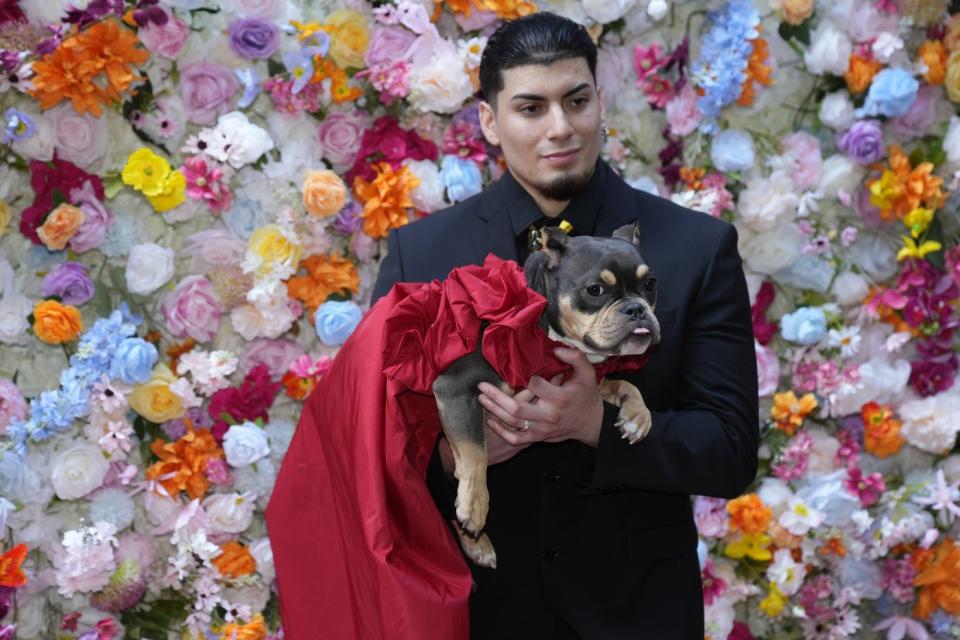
[[353, 162, 420, 238]]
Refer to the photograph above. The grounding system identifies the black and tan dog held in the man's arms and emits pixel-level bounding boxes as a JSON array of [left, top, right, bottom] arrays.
[[433, 223, 660, 568]]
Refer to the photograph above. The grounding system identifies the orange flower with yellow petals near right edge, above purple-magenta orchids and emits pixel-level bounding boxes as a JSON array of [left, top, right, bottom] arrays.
[[867, 145, 944, 222]]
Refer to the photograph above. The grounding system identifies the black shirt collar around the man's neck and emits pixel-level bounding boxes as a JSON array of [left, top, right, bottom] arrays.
[[500, 160, 608, 236]]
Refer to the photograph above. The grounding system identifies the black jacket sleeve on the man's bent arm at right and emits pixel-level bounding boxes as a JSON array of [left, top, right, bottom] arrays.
[[587, 225, 760, 498]]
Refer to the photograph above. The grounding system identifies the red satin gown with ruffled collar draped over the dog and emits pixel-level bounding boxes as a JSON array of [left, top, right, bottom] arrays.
[[266, 255, 645, 640]]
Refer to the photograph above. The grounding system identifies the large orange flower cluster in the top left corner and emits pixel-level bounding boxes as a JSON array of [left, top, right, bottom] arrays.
[[31, 20, 150, 117]]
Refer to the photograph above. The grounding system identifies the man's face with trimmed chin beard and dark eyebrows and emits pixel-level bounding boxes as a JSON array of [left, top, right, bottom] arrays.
[[480, 58, 604, 201]]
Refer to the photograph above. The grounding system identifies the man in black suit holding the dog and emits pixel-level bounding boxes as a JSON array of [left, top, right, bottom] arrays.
[[374, 13, 759, 640]]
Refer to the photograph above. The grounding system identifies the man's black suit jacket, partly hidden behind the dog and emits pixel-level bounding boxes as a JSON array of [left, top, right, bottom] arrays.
[[374, 163, 759, 640]]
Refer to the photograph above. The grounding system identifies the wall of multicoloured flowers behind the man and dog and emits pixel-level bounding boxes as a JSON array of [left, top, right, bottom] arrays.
[[0, 0, 960, 640]]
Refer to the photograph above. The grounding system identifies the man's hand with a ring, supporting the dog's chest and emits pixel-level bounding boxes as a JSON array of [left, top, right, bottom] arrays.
[[478, 348, 603, 448]]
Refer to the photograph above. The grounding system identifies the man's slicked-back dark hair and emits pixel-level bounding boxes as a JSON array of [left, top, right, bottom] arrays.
[[480, 11, 597, 108]]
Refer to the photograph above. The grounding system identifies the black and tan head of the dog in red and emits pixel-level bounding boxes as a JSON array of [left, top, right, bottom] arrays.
[[524, 223, 660, 356]]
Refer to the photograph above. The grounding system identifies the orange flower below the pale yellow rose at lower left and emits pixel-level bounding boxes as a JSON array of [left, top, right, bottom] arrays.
[[147, 427, 223, 499]]
